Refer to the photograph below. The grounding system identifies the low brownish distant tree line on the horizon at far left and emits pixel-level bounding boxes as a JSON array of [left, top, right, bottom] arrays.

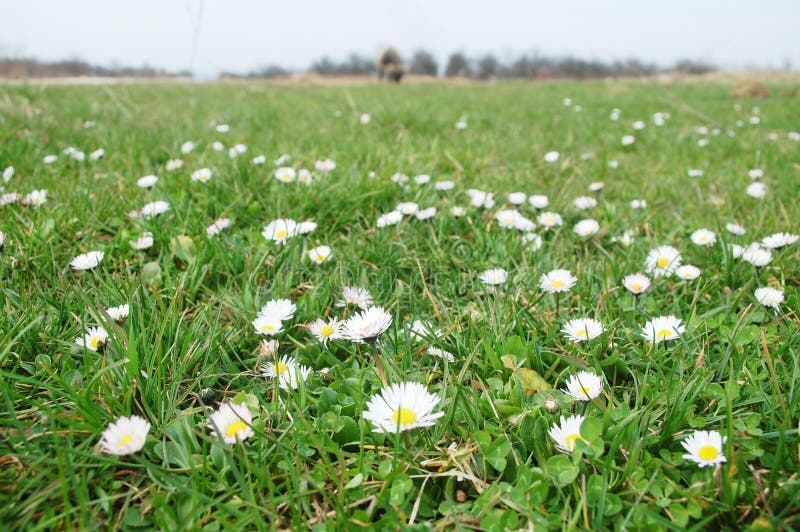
[[0, 57, 192, 78]]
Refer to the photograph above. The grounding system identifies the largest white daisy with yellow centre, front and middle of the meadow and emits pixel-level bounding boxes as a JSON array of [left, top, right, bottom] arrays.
[[362, 382, 444, 433]]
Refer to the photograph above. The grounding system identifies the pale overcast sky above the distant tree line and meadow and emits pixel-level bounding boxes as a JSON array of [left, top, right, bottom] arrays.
[[0, 0, 800, 77]]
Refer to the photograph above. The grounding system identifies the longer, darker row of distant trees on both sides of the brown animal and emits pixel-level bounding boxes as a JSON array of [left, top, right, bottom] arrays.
[[224, 50, 716, 80]]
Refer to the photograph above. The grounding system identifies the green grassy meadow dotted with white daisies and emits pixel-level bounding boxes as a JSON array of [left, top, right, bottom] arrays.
[[0, 81, 800, 530]]
